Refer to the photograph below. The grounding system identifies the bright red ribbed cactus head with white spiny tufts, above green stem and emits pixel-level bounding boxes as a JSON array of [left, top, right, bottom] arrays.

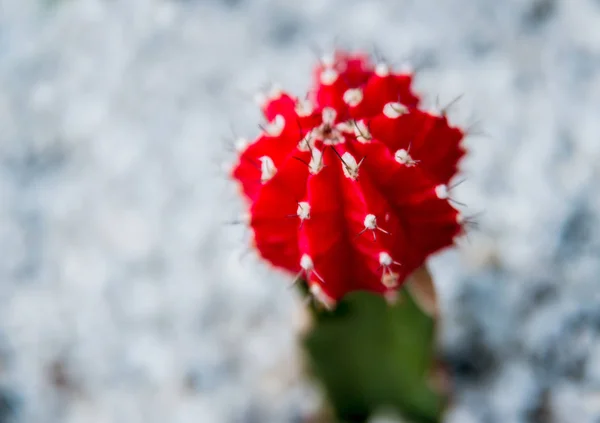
[[233, 52, 465, 306]]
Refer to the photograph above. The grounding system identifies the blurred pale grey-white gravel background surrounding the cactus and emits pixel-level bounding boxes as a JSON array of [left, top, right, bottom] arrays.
[[0, 0, 600, 423]]
